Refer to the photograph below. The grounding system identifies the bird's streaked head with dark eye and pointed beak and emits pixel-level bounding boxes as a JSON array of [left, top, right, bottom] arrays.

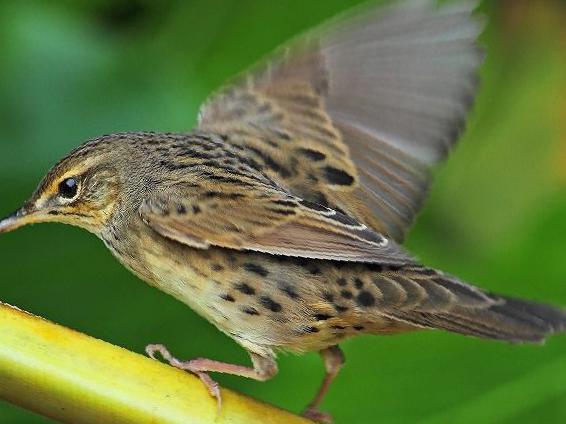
[[0, 135, 125, 234]]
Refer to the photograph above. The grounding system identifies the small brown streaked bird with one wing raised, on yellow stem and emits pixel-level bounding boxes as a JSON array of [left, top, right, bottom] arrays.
[[0, 1, 566, 421]]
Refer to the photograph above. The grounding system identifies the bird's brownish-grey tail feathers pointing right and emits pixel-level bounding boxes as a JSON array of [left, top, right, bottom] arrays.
[[380, 270, 566, 343]]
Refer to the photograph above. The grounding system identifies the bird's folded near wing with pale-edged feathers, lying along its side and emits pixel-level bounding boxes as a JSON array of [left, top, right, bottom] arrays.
[[139, 174, 413, 265]]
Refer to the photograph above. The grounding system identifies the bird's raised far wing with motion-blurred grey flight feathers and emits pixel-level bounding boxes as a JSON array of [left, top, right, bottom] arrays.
[[199, 0, 481, 240]]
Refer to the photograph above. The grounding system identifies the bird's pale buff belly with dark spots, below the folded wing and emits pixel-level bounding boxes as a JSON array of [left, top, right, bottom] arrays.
[[129, 235, 384, 355]]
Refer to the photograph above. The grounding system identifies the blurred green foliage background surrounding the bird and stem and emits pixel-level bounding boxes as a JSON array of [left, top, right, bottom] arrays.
[[0, 0, 566, 424]]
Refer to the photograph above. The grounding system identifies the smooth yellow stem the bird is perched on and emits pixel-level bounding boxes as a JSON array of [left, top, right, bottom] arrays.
[[0, 302, 312, 424]]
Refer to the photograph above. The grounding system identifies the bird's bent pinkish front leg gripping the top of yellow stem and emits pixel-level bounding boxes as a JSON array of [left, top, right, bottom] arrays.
[[145, 344, 277, 411]]
